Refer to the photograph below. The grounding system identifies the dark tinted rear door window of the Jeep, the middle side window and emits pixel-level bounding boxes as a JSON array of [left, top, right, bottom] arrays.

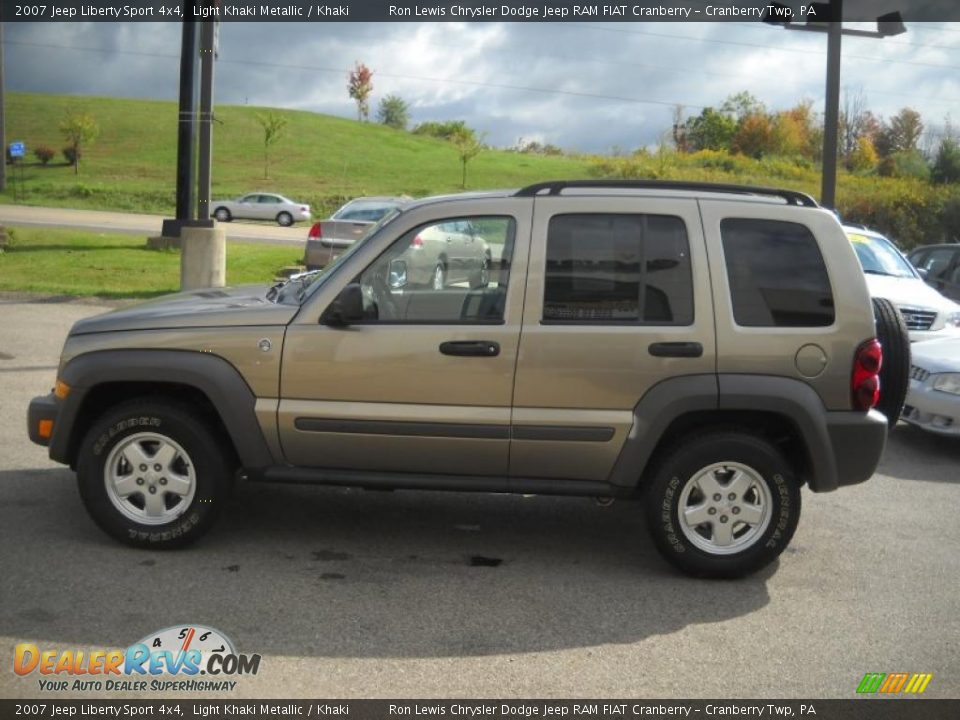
[[543, 214, 693, 325]]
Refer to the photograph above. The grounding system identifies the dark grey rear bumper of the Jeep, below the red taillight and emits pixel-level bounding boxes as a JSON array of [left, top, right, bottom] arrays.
[[811, 410, 887, 492]]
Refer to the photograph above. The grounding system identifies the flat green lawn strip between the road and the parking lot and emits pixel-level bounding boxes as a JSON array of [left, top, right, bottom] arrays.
[[0, 227, 303, 298]]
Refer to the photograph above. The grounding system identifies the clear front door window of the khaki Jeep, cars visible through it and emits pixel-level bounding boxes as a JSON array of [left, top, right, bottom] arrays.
[[357, 217, 516, 325]]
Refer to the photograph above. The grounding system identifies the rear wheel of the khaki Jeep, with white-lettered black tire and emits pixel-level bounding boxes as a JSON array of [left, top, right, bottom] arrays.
[[645, 430, 800, 578]]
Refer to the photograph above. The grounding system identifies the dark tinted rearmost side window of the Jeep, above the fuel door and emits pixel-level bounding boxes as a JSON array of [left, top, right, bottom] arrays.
[[720, 218, 834, 327]]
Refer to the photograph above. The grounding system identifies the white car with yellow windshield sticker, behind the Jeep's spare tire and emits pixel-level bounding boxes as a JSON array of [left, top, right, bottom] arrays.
[[844, 226, 960, 343]]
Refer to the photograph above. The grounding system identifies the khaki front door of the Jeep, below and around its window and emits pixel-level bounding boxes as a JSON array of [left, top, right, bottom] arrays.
[[278, 199, 530, 476]]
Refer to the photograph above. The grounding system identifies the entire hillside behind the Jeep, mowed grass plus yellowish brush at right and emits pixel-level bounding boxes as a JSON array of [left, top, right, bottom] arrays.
[[0, 93, 960, 247]]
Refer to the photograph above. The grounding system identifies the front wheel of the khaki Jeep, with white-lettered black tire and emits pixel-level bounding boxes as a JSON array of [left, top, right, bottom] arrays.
[[77, 399, 234, 549]]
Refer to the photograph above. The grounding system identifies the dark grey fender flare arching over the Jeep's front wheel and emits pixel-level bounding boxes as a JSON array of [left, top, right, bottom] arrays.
[[50, 350, 279, 468]]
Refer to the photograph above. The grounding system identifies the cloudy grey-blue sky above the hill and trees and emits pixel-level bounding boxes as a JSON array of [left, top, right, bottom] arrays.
[[5, 22, 960, 151]]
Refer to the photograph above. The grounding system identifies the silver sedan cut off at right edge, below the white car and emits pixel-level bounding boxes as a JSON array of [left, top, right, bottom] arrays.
[[901, 339, 960, 437]]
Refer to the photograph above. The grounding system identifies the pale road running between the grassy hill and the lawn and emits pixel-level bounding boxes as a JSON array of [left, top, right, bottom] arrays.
[[0, 205, 308, 245]]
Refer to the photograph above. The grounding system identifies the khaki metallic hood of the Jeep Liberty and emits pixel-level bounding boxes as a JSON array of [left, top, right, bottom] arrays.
[[70, 285, 300, 335]]
